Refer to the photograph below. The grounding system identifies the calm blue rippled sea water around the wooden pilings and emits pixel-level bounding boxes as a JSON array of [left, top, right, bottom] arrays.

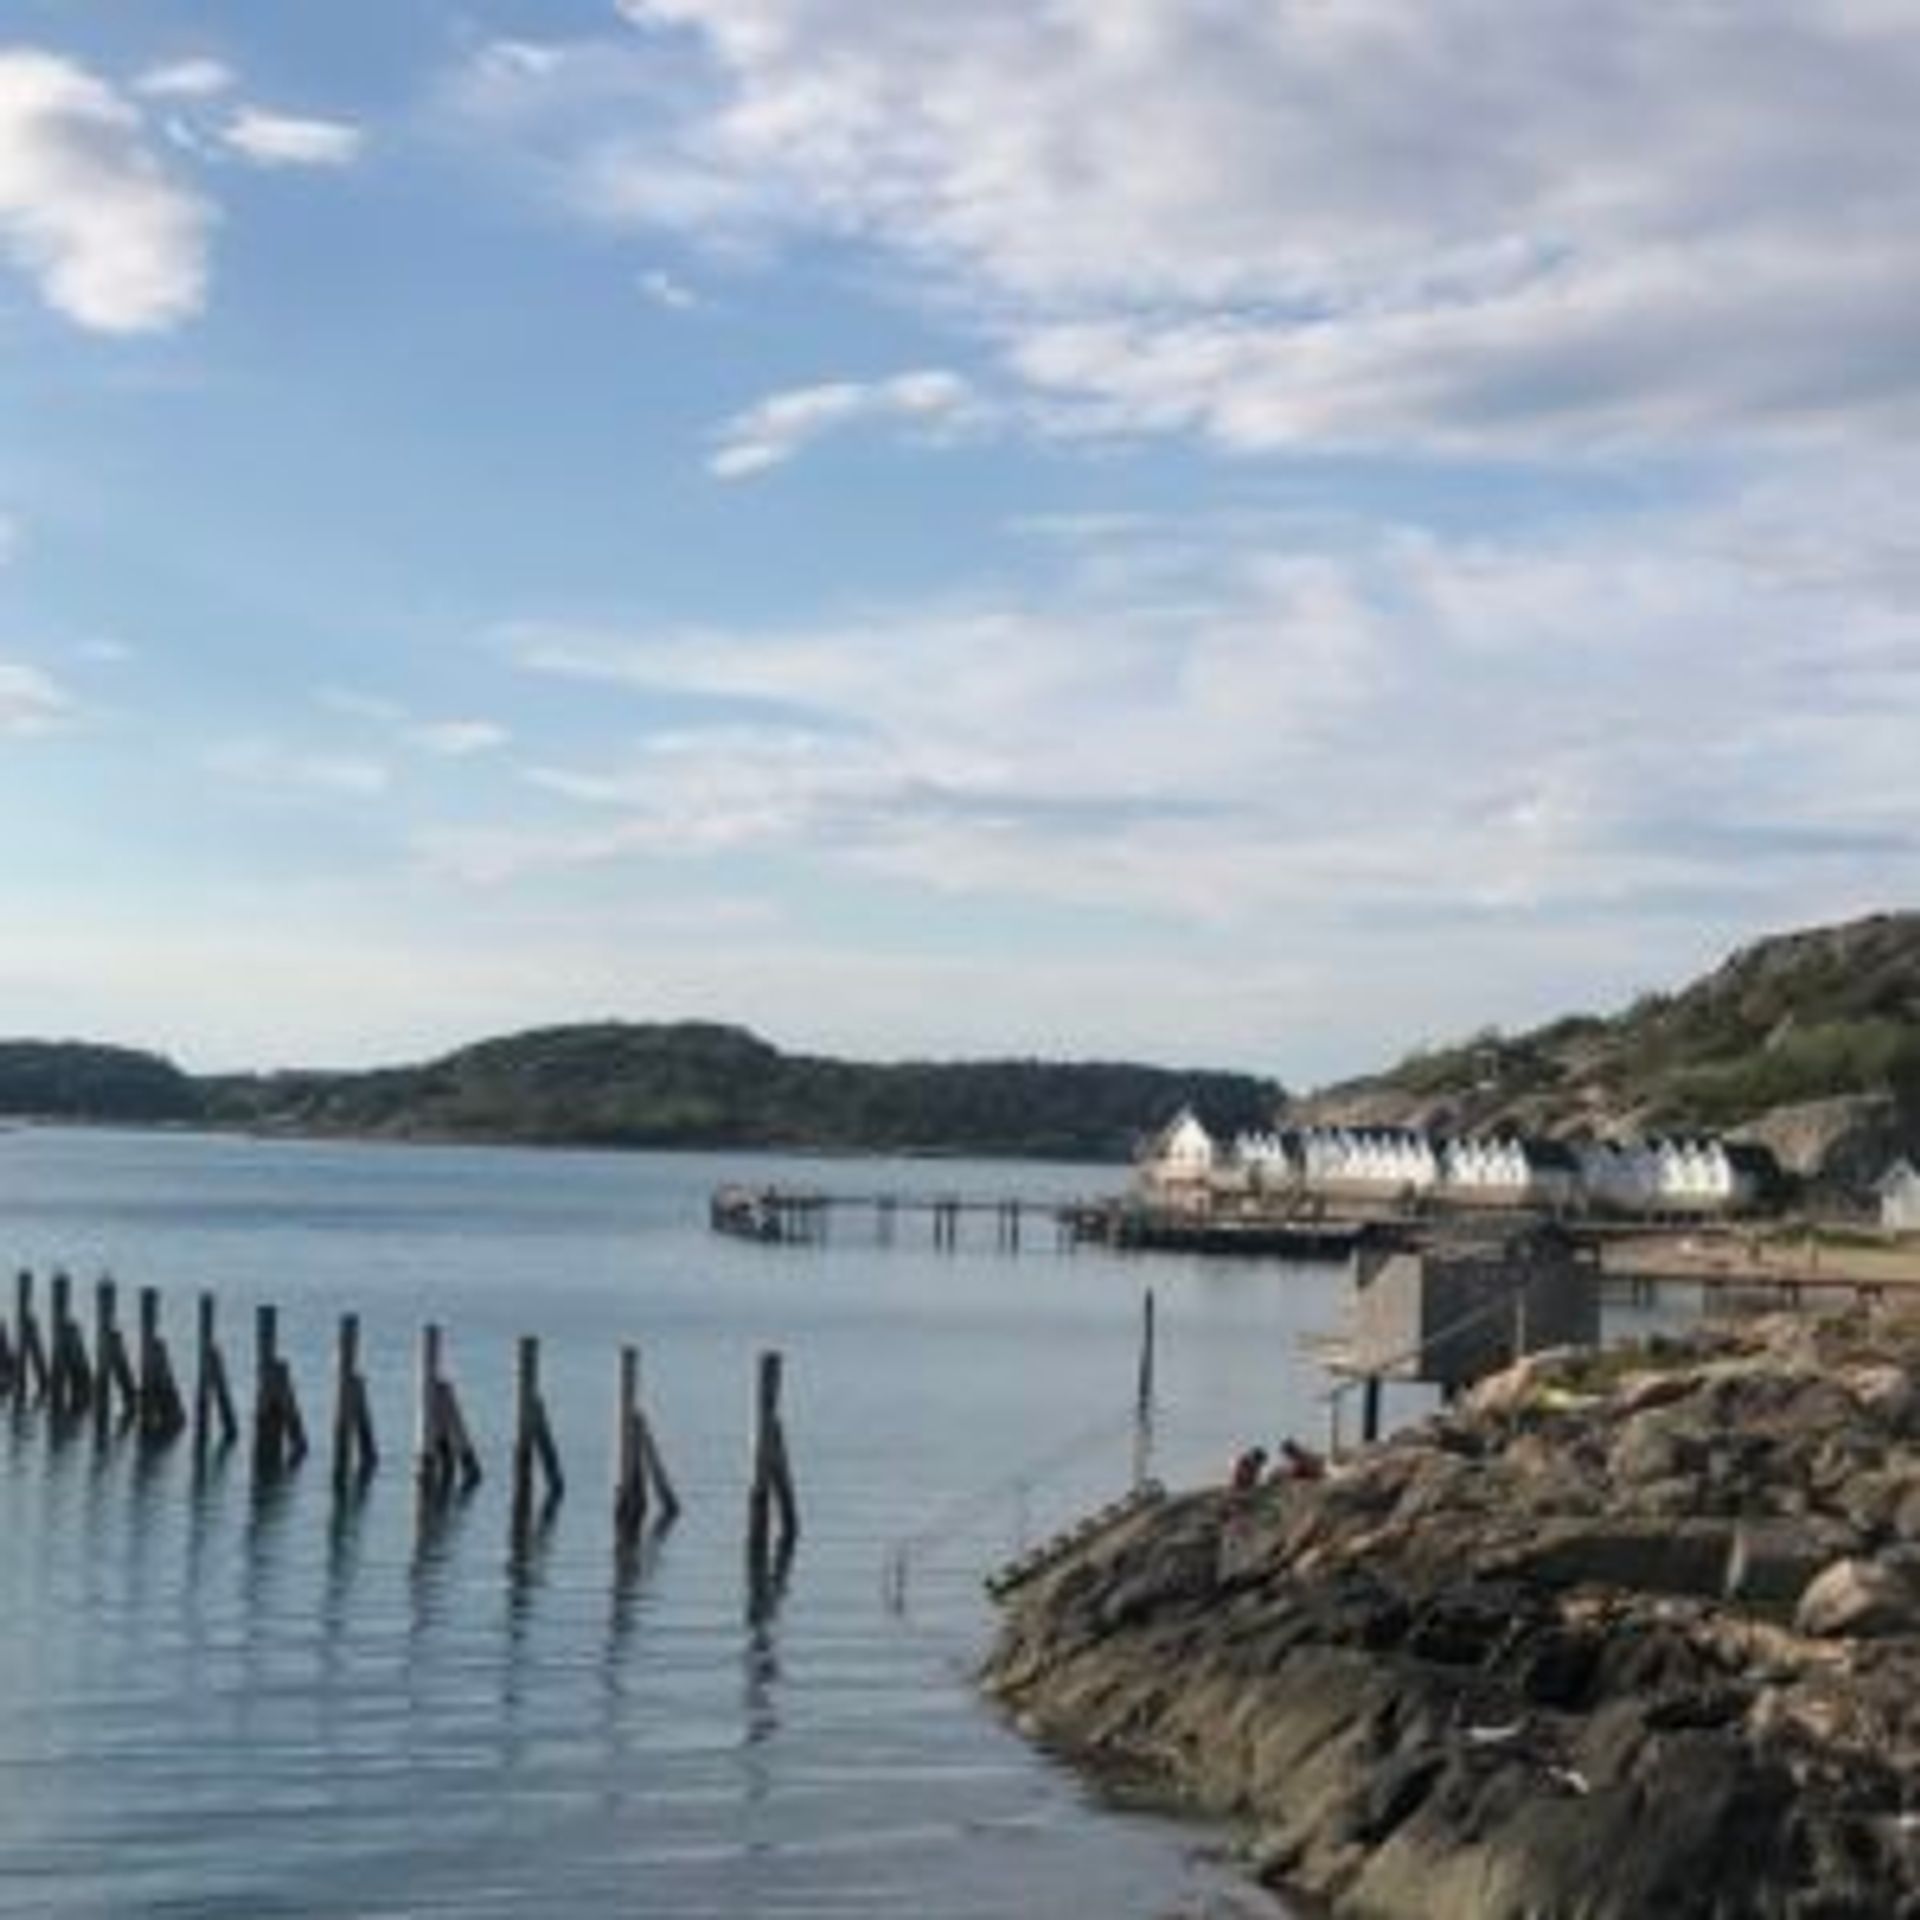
[[0, 1131, 1367, 1920]]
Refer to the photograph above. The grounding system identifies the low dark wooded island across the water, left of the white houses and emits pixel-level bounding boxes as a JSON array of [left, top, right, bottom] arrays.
[[0, 1021, 1284, 1162]]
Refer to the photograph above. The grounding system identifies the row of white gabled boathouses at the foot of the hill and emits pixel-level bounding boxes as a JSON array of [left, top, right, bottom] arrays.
[[1140, 1112, 1778, 1213]]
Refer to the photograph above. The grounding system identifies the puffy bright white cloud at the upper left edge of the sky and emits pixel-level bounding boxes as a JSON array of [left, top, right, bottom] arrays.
[[0, 50, 213, 334]]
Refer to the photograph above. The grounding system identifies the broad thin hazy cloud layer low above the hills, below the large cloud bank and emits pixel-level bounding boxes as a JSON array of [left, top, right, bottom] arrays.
[[493, 463, 1920, 952]]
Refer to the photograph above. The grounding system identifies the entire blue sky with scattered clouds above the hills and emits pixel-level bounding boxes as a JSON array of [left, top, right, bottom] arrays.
[[0, 0, 1920, 1085]]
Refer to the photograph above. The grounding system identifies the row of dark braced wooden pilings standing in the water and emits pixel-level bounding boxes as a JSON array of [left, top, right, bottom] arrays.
[[0, 1271, 801, 1569]]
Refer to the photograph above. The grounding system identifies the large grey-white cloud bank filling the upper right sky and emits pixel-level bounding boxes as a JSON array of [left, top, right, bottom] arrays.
[[449, 0, 1920, 451]]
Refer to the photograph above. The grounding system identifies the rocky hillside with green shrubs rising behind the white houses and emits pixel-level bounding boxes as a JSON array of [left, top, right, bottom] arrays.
[[1288, 914, 1920, 1185]]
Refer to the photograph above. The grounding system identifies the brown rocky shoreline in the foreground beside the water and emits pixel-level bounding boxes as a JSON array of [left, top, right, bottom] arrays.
[[985, 1317, 1920, 1920]]
